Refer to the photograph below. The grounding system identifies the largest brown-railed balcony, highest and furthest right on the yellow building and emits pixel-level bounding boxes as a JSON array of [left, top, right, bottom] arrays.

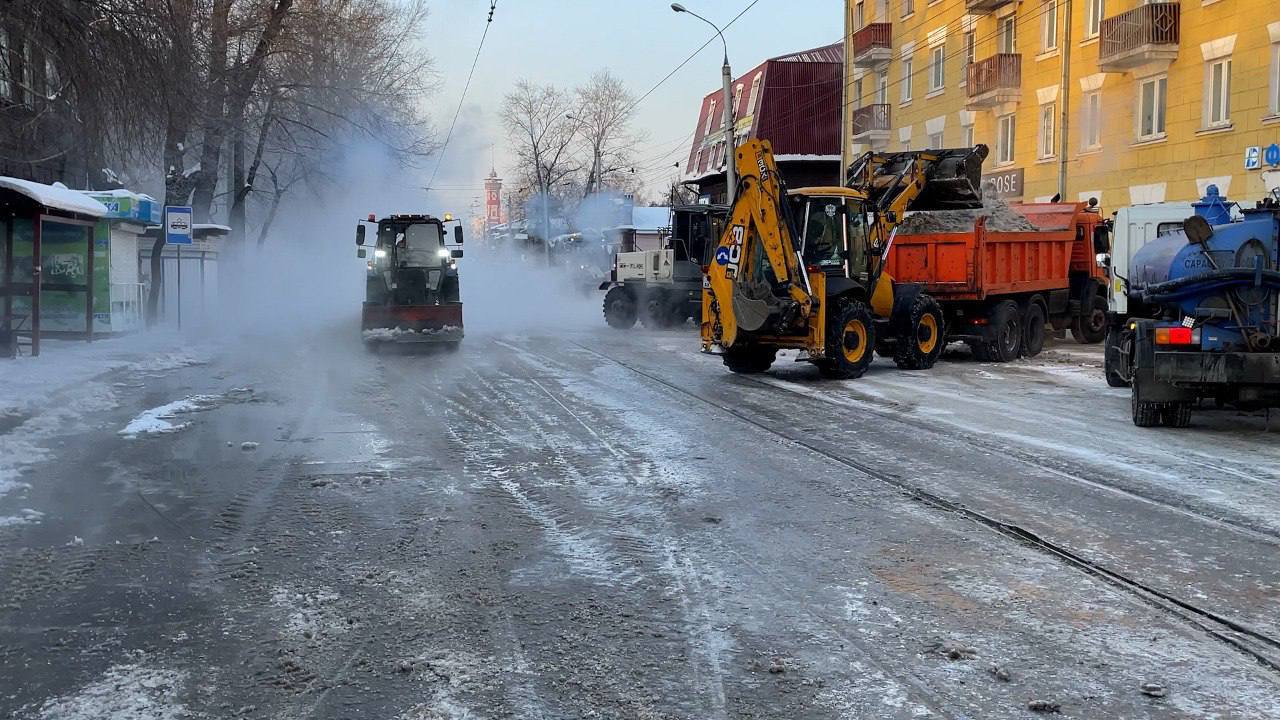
[[1098, 3, 1181, 73]]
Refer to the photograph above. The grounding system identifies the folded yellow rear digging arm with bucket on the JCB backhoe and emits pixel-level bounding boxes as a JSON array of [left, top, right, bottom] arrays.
[[707, 140, 815, 347]]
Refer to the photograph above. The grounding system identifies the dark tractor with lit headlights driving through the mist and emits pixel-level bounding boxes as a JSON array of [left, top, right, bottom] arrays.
[[356, 214, 463, 346]]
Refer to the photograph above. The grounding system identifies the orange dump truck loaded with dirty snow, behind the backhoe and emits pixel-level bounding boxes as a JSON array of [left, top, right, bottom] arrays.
[[887, 202, 1107, 363]]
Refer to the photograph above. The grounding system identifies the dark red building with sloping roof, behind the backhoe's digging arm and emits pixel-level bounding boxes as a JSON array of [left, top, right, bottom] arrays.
[[684, 42, 845, 202]]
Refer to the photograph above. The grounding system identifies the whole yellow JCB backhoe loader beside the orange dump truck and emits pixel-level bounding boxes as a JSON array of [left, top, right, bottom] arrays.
[[701, 140, 987, 378]]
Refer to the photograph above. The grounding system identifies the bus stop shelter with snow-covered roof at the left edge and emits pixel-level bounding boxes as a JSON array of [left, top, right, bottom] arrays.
[[0, 177, 108, 357]]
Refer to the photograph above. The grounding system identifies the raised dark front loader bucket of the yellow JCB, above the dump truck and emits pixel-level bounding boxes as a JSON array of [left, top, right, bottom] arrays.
[[847, 145, 988, 210]]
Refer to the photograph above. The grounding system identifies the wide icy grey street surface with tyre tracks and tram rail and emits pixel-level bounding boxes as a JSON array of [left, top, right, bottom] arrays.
[[0, 328, 1280, 720]]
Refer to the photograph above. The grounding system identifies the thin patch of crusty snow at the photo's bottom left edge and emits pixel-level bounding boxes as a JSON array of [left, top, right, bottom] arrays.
[[26, 664, 191, 720]]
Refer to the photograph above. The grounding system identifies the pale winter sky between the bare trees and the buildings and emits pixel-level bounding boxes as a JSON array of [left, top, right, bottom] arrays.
[[424, 0, 844, 211]]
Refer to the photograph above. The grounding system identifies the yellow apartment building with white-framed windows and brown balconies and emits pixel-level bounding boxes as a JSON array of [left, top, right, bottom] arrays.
[[842, 0, 1280, 210]]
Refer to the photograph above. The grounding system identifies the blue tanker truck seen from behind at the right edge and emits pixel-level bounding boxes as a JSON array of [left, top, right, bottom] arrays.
[[1100, 186, 1280, 428]]
